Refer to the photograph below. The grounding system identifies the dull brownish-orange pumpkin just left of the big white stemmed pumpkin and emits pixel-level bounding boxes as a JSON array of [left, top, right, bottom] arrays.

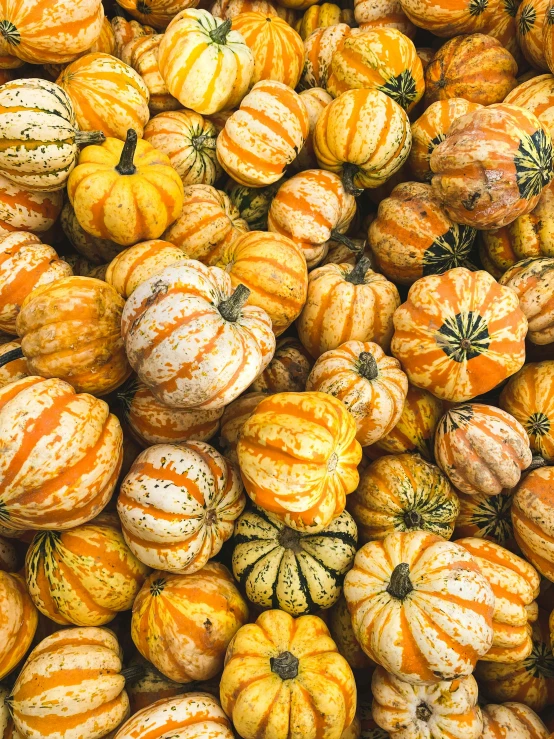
[[17, 274, 131, 395]]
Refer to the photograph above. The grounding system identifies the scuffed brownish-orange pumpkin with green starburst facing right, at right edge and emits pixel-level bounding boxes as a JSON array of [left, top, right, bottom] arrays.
[[431, 104, 553, 229]]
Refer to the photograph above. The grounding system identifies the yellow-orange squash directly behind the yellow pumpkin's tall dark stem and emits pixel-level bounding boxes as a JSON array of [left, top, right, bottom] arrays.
[[57, 52, 151, 139]]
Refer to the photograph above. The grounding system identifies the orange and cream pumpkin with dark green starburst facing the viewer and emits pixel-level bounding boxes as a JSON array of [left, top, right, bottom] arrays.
[[391, 267, 527, 402]]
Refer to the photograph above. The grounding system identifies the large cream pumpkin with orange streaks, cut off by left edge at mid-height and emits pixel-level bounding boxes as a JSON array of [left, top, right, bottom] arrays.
[[0, 377, 123, 532]]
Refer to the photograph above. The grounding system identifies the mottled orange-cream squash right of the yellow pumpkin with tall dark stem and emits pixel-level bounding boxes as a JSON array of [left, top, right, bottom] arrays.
[[164, 185, 248, 264]]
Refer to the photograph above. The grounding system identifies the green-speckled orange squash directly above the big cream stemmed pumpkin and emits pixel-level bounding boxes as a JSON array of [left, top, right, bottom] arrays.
[[347, 454, 460, 542]]
